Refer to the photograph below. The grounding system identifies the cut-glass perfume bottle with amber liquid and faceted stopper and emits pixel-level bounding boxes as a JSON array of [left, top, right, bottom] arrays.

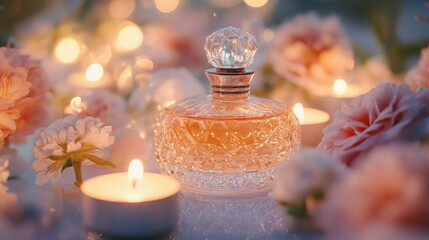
[[154, 27, 301, 194]]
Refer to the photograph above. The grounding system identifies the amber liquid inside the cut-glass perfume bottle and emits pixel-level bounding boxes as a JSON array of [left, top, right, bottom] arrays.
[[157, 110, 294, 173]]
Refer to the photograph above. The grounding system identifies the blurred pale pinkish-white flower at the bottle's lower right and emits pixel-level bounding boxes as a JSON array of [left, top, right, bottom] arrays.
[[273, 148, 345, 218]]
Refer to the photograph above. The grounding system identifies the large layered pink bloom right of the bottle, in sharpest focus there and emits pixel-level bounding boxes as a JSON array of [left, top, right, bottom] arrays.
[[318, 82, 429, 166]]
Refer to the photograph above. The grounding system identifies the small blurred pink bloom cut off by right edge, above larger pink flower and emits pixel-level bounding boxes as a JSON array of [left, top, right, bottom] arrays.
[[405, 47, 429, 89]]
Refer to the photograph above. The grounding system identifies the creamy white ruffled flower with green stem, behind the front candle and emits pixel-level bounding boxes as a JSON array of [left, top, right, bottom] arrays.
[[33, 115, 115, 185]]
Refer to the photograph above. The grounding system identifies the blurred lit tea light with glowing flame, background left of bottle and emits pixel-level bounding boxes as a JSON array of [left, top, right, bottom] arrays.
[[68, 63, 114, 88]]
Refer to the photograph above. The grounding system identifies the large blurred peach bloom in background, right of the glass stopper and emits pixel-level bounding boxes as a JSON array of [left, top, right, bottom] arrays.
[[268, 13, 354, 92]]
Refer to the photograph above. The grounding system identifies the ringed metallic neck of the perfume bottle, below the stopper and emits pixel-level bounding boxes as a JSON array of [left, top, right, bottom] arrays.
[[206, 69, 254, 101]]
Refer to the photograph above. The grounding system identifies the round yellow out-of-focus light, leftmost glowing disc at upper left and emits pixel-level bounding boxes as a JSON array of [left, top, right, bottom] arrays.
[[55, 38, 80, 64]]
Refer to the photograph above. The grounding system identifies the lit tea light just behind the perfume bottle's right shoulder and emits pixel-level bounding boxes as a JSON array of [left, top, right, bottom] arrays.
[[293, 103, 330, 147]]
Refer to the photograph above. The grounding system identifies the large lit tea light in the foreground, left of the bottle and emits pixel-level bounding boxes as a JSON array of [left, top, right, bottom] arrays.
[[81, 159, 180, 238]]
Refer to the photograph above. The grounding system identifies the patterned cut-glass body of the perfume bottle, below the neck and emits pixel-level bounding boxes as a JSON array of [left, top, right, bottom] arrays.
[[155, 96, 300, 192]]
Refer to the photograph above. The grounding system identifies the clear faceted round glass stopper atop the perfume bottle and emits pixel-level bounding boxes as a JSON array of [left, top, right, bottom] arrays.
[[204, 27, 258, 69]]
